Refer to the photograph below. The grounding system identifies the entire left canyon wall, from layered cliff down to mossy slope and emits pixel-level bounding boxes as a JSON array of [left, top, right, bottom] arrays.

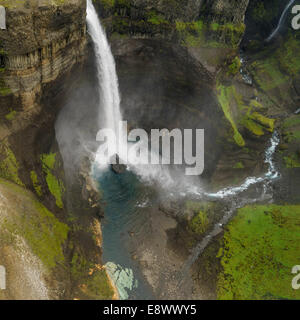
[[0, 0, 114, 299]]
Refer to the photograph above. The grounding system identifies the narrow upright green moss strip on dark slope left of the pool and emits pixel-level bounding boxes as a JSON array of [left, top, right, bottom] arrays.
[[41, 153, 65, 208]]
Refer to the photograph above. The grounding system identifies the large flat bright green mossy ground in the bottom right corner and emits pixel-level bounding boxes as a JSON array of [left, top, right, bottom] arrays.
[[218, 205, 300, 299]]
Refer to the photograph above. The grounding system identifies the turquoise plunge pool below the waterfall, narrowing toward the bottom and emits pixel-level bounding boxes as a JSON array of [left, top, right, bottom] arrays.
[[95, 170, 153, 300]]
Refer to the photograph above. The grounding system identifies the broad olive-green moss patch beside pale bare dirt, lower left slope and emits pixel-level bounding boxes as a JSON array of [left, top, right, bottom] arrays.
[[0, 179, 69, 269]]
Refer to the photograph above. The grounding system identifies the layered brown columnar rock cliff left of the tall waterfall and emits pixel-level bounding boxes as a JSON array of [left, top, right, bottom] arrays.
[[0, 0, 86, 139]]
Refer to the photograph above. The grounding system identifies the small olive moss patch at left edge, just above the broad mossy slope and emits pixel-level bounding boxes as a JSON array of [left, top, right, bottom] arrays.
[[0, 142, 23, 186]]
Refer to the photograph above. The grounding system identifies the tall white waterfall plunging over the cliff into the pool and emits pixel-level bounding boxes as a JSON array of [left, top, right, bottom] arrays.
[[87, 0, 122, 152]]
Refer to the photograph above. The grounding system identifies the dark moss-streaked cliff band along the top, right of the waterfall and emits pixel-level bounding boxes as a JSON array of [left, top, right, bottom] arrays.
[[94, 0, 249, 48]]
